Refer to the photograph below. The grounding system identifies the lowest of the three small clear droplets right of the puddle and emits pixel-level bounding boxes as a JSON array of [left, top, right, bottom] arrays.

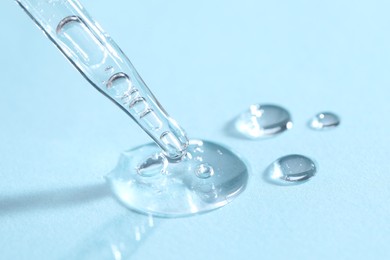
[[265, 154, 317, 185]]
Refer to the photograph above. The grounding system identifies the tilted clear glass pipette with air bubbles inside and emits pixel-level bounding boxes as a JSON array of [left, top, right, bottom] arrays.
[[17, 0, 188, 159]]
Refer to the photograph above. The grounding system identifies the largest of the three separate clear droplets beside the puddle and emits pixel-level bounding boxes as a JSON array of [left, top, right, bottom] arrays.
[[235, 104, 292, 139]]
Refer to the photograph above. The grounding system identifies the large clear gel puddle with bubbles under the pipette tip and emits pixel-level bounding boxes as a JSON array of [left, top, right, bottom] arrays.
[[107, 140, 248, 217]]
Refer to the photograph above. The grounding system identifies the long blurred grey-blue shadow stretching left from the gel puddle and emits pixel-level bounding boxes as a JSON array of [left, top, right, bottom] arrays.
[[0, 183, 111, 217]]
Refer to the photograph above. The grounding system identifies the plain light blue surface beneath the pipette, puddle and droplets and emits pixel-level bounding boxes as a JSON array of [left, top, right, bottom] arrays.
[[0, 0, 390, 259]]
